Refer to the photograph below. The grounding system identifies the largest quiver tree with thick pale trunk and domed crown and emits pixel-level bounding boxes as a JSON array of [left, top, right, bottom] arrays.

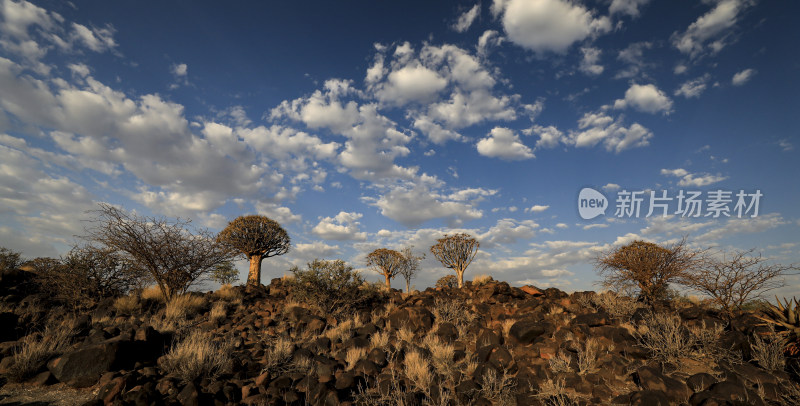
[[217, 215, 291, 285]]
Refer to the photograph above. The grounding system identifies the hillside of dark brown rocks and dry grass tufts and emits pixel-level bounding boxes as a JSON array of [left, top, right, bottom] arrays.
[[0, 266, 800, 406]]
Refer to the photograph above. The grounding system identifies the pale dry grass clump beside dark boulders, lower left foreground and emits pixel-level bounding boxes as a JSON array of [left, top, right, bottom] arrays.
[[158, 331, 233, 382]]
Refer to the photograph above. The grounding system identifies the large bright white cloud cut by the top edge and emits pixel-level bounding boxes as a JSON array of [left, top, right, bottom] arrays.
[[492, 0, 611, 52]]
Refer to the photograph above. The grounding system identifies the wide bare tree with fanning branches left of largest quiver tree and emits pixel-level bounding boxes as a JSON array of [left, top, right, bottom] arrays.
[[84, 204, 232, 300]]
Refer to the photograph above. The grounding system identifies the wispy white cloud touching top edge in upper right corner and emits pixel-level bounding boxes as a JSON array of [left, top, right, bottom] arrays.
[[672, 0, 751, 57]]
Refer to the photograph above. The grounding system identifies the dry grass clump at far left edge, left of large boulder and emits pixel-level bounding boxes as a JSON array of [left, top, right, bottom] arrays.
[[7, 319, 75, 382]]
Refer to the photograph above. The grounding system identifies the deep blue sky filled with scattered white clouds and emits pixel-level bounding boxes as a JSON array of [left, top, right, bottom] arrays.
[[0, 0, 800, 294]]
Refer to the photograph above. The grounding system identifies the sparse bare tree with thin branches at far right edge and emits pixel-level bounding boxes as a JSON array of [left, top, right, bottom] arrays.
[[681, 249, 798, 318]]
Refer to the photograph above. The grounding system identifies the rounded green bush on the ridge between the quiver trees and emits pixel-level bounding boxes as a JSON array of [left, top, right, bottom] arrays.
[[288, 259, 382, 315]]
